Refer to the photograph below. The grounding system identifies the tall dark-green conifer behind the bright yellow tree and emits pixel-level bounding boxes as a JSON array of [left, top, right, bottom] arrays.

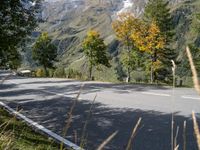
[[144, 0, 177, 80]]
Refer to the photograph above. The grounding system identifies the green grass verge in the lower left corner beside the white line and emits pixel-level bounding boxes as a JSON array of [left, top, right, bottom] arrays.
[[0, 108, 59, 150]]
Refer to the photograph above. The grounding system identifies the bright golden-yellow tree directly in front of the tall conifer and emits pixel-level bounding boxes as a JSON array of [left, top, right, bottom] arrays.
[[131, 22, 165, 83]]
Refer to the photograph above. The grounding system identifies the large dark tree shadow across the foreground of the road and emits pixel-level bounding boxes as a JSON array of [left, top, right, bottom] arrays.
[[4, 97, 197, 150]]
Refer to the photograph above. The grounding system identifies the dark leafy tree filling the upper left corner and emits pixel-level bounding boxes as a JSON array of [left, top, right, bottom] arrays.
[[0, 0, 40, 69]]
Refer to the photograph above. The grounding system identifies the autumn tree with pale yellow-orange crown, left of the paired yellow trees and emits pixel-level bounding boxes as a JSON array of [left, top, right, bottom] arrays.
[[112, 12, 139, 82]]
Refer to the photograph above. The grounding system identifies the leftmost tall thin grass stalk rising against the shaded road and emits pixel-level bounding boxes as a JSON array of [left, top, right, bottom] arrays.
[[60, 84, 84, 150]]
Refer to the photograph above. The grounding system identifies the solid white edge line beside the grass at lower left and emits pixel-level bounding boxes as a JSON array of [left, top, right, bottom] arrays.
[[0, 102, 84, 150]]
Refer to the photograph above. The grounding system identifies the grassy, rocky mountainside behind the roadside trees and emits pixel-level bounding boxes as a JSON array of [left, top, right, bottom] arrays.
[[23, 0, 200, 80]]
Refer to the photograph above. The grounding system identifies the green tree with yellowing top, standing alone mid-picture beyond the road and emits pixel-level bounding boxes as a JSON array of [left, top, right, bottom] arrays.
[[82, 30, 110, 79]]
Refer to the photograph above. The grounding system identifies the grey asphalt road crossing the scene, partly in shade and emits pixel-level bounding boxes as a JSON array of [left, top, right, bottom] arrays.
[[0, 71, 200, 150]]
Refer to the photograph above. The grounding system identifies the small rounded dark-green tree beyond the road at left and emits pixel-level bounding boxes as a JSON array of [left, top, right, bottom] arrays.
[[32, 32, 57, 75]]
